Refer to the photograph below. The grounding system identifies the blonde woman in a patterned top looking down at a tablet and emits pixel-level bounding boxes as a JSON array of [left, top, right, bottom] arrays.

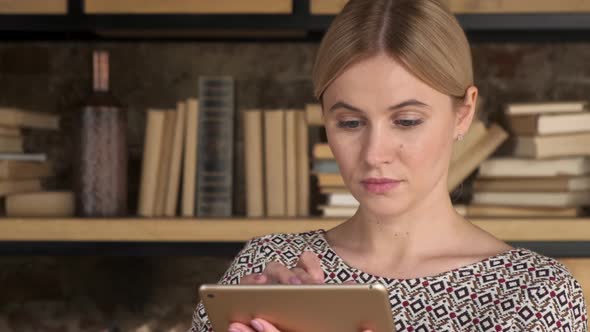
[[192, 0, 587, 332]]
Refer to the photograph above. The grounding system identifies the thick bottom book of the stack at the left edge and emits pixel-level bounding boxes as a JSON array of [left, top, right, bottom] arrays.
[[6, 191, 75, 218]]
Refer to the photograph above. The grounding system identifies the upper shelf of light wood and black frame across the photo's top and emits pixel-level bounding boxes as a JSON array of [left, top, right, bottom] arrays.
[[0, 0, 590, 41]]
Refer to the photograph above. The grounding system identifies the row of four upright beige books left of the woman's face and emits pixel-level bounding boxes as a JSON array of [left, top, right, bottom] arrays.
[[243, 109, 310, 217]]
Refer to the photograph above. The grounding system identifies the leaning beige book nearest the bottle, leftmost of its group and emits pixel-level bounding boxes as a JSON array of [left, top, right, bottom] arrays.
[[137, 109, 166, 217]]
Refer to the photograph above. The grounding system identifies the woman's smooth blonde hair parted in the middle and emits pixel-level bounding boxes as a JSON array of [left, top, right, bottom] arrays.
[[312, 0, 473, 100]]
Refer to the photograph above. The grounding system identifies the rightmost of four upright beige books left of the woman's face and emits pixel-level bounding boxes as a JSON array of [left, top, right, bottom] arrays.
[[295, 112, 310, 217]]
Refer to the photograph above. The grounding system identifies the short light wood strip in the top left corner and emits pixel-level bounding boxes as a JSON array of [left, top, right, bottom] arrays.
[[0, 0, 68, 15]]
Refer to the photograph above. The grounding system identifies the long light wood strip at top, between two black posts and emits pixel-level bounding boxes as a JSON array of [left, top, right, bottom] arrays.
[[85, 0, 293, 14]]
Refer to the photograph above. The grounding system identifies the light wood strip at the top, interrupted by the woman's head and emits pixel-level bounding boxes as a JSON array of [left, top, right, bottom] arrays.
[[310, 0, 590, 15]]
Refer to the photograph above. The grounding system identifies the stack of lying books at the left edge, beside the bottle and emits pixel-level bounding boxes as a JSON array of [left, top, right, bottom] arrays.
[[0, 107, 73, 217]]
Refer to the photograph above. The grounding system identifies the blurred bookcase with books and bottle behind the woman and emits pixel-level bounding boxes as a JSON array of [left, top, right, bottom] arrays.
[[0, 0, 590, 332]]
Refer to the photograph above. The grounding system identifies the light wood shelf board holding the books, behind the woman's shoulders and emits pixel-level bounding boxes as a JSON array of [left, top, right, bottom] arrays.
[[0, 218, 590, 243]]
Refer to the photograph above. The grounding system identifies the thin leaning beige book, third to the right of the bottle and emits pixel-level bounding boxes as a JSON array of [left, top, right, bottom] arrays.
[[164, 102, 186, 217]]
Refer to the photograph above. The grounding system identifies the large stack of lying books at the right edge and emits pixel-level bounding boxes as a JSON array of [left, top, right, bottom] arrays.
[[466, 101, 590, 217]]
